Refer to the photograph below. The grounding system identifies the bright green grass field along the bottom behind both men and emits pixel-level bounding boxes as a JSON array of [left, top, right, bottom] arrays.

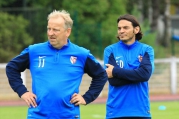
[[0, 101, 179, 119]]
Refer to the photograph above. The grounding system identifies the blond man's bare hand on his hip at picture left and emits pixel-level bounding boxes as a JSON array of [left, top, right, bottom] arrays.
[[21, 92, 37, 108]]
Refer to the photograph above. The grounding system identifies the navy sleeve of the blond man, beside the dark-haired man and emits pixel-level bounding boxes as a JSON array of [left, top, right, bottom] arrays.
[[83, 54, 107, 104]]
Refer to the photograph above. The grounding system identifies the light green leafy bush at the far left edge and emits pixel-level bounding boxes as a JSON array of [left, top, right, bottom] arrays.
[[0, 12, 33, 63]]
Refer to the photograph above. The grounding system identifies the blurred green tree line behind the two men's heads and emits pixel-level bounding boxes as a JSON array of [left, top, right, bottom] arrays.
[[0, 0, 179, 63]]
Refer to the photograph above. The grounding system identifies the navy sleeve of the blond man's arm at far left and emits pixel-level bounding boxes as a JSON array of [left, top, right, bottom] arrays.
[[6, 49, 29, 97]]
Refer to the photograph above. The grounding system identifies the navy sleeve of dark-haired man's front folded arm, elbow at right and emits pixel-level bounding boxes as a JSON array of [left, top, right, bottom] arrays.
[[112, 52, 154, 82]]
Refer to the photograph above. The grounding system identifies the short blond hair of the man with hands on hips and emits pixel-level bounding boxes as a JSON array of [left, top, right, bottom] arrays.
[[47, 10, 73, 29]]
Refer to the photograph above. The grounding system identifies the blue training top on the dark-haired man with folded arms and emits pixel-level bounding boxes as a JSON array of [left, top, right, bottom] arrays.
[[104, 41, 154, 119]]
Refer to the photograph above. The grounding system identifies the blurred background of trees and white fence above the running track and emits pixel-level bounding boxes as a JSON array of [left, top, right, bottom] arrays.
[[0, 0, 179, 101]]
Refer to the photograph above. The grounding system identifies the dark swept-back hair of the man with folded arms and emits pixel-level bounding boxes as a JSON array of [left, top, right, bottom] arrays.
[[117, 14, 143, 41]]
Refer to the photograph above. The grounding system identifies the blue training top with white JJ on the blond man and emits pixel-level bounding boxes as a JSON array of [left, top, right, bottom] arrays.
[[6, 40, 107, 119]]
